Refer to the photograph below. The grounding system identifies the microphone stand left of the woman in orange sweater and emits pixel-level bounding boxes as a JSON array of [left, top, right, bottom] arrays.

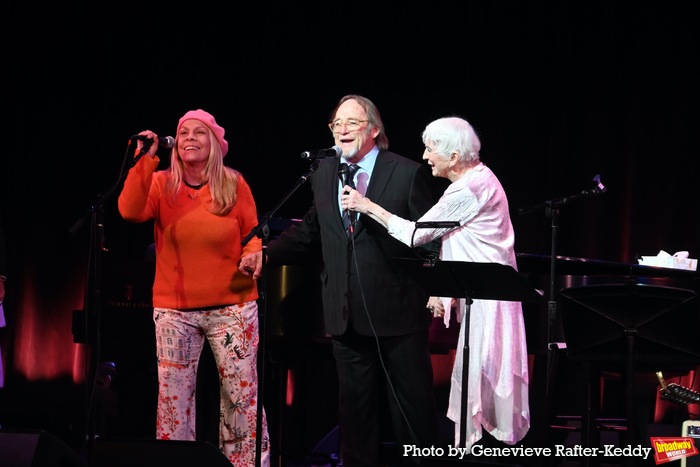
[[68, 146, 148, 456]]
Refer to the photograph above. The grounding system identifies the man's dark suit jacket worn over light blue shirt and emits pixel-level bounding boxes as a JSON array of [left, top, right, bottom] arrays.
[[267, 151, 439, 336]]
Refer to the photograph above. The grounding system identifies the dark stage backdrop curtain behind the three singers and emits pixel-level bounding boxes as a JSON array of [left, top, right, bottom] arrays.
[[0, 1, 700, 452]]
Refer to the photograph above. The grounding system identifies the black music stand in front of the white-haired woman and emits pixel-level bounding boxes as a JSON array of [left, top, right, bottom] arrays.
[[394, 258, 543, 447]]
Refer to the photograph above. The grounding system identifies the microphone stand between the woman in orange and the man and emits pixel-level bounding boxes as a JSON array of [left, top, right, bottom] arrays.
[[241, 159, 318, 467]]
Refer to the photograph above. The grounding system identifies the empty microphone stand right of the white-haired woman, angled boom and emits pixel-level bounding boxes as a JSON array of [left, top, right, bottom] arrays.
[[518, 175, 606, 450]]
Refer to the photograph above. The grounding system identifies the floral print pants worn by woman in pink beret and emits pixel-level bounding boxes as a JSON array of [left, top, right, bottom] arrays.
[[153, 301, 270, 467]]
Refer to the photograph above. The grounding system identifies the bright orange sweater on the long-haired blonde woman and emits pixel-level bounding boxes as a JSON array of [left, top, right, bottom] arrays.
[[118, 156, 262, 310]]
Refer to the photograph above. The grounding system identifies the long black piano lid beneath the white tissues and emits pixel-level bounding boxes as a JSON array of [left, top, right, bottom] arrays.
[[516, 253, 700, 280]]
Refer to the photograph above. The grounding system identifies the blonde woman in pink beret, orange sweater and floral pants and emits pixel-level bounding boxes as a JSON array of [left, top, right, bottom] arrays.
[[118, 109, 270, 467]]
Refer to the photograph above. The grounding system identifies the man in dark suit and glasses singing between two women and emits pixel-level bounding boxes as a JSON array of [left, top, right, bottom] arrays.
[[267, 95, 439, 467]]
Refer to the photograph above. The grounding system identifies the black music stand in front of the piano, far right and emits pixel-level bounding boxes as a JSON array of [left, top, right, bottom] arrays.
[[560, 283, 700, 447]]
